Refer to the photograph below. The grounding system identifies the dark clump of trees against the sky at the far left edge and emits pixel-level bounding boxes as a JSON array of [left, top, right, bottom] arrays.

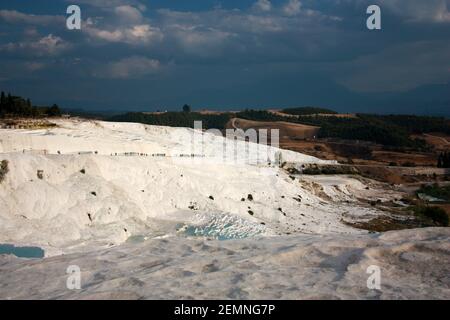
[[0, 91, 61, 118]]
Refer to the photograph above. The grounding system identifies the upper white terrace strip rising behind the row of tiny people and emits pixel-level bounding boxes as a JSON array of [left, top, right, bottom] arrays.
[[0, 120, 330, 163]]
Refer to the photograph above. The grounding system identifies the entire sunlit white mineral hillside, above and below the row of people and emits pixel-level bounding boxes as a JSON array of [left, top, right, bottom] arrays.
[[0, 120, 396, 256]]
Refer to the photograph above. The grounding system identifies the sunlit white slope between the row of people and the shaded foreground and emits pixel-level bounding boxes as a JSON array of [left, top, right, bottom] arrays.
[[0, 153, 395, 256]]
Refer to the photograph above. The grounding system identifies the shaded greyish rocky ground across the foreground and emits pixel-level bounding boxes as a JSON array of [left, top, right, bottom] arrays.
[[0, 228, 450, 299]]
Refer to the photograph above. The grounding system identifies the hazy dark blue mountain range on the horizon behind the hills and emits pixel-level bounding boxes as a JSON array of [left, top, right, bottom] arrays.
[[51, 82, 450, 117]]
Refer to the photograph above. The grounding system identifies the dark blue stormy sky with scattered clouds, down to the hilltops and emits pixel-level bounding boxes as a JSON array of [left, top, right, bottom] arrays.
[[0, 0, 450, 114]]
